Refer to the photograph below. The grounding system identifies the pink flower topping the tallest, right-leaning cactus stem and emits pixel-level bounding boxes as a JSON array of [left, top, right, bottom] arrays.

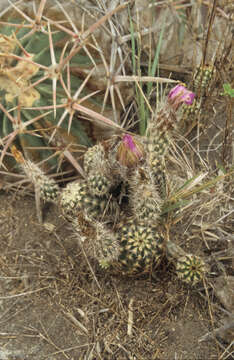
[[168, 84, 196, 110]]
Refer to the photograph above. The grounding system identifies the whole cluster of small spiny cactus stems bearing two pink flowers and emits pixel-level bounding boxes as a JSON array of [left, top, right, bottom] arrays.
[[11, 85, 206, 285]]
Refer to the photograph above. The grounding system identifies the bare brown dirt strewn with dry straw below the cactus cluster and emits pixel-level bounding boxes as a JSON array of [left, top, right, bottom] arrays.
[[0, 192, 229, 360]]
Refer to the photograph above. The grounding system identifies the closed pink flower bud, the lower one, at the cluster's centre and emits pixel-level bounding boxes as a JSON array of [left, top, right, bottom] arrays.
[[116, 134, 144, 167]]
